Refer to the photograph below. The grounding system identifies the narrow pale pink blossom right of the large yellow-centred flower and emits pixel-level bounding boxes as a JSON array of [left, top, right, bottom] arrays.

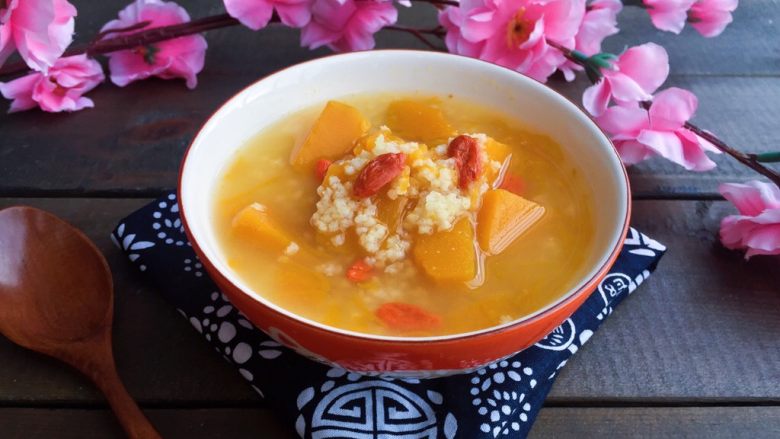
[[559, 0, 623, 81]]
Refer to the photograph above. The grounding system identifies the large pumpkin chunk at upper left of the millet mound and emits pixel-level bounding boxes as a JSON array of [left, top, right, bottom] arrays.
[[290, 101, 369, 171]]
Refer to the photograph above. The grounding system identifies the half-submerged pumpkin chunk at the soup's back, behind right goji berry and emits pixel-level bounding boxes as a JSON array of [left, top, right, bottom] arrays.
[[387, 99, 454, 142]]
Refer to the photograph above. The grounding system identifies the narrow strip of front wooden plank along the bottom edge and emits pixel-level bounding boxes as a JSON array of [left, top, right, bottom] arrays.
[[0, 407, 780, 439]]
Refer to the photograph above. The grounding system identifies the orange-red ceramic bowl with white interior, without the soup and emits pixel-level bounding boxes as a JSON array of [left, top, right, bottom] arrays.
[[179, 51, 631, 377]]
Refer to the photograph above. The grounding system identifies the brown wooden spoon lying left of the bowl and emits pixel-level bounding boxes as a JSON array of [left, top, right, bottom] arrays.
[[0, 207, 160, 439]]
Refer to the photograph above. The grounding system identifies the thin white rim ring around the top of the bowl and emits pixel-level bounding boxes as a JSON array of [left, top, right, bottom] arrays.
[[177, 49, 632, 344]]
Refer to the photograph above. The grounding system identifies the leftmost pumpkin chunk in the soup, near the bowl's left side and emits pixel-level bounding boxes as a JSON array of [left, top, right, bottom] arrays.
[[233, 203, 293, 252]]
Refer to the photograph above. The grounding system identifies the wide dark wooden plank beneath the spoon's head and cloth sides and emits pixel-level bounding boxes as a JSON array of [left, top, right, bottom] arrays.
[[0, 199, 780, 407]]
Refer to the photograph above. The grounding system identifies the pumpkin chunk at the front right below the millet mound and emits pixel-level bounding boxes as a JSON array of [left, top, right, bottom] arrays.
[[414, 218, 478, 284]]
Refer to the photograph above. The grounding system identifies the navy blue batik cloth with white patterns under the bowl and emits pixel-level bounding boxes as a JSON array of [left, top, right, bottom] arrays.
[[112, 193, 666, 439]]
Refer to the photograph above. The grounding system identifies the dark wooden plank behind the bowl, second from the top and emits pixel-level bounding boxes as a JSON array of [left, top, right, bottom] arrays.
[[0, 73, 780, 197]]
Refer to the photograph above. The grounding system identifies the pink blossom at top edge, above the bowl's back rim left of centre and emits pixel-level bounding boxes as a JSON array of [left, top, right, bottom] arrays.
[[301, 0, 398, 52]]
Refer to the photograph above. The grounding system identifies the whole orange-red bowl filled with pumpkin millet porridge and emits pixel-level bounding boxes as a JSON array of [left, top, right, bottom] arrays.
[[179, 51, 630, 377]]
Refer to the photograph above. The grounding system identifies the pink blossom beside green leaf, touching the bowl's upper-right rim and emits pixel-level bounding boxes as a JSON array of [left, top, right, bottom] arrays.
[[582, 43, 669, 116]]
